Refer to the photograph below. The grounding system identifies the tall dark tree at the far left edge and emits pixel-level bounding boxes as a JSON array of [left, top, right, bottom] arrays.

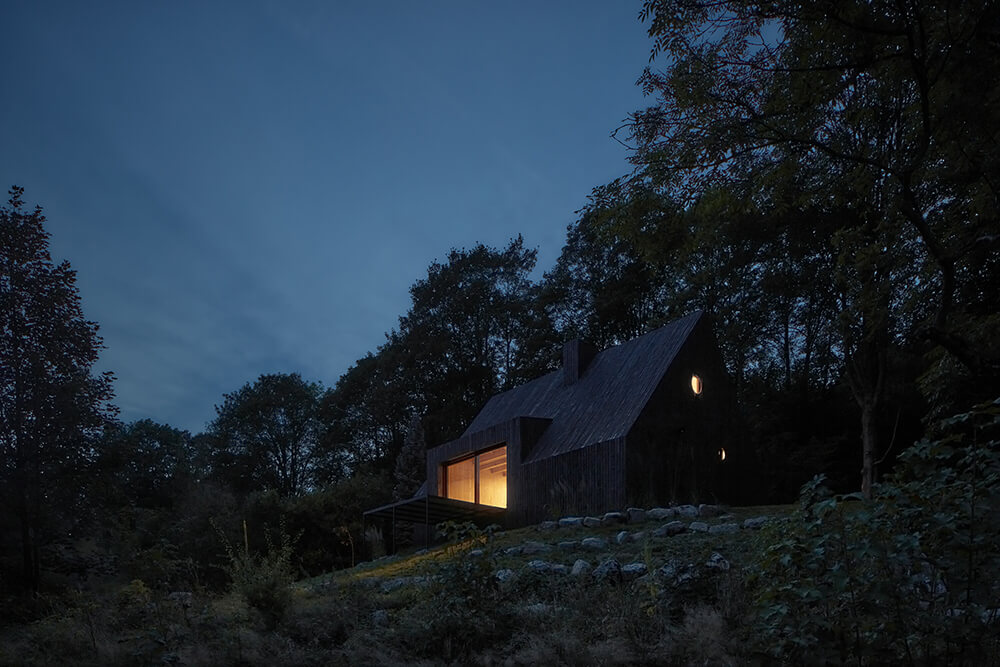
[[0, 187, 114, 592]]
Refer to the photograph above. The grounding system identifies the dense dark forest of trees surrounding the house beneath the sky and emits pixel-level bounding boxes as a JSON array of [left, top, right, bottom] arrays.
[[0, 0, 1000, 656]]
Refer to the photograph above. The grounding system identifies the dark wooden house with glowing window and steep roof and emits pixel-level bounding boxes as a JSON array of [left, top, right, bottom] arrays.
[[367, 312, 739, 527]]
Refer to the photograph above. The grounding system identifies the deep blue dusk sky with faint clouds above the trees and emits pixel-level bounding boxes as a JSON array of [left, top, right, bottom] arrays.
[[0, 0, 649, 433]]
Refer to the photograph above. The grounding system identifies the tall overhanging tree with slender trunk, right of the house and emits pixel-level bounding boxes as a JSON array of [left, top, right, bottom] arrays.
[[628, 0, 1000, 490]]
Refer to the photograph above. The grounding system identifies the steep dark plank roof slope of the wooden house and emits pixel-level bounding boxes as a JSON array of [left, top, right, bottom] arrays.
[[462, 311, 702, 463]]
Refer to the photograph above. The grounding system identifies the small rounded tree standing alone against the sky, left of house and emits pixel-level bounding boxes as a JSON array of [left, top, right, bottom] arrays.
[[209, 373, 323, 496]]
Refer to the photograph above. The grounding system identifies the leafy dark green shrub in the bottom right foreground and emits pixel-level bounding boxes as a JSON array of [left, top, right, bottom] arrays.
[[756, 399, 1000, 664]]
